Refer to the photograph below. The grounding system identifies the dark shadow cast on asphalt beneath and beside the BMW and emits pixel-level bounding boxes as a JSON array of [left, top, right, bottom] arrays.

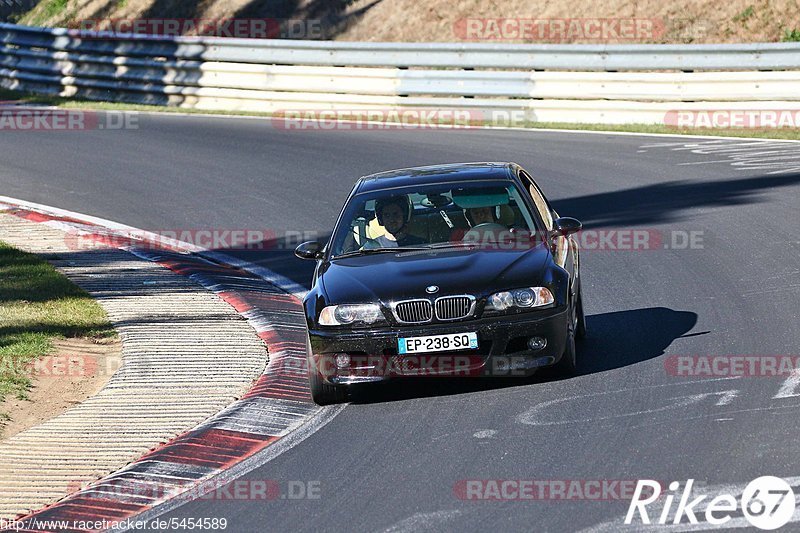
[[351, 307, 697, 404]]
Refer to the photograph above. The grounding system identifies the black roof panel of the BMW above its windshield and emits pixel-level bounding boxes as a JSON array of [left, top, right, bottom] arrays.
[[356, 163, 515, 193]]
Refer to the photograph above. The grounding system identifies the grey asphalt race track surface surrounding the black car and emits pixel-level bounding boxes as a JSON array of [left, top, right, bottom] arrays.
[[0, 116, 800, 531]]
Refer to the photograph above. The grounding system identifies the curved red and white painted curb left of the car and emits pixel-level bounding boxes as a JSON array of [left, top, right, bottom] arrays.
[[0, 197, 343, 531]]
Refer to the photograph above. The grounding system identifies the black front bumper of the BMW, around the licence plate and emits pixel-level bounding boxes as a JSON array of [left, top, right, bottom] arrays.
[[309, 307, 569, 385]]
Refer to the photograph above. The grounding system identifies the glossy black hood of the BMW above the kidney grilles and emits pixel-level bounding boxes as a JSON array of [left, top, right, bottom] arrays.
[[320, 244, 550, 304]]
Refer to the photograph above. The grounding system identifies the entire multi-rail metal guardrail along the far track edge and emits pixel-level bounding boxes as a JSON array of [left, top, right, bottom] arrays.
[[0, 24, 800, 122]]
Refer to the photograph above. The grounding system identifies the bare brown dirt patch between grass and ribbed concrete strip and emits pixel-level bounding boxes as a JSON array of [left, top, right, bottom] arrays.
[[0, 339, 122, 441]]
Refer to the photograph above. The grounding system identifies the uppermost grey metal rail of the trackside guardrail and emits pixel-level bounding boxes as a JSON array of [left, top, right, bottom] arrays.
[[0, 24, 800, 71]]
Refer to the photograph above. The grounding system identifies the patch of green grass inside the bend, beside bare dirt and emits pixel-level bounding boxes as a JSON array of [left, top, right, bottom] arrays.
[[0, 242, 116, 410]]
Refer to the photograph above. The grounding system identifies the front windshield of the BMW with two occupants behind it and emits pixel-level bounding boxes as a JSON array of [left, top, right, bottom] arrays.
[[331, 181, 536, 257]]
